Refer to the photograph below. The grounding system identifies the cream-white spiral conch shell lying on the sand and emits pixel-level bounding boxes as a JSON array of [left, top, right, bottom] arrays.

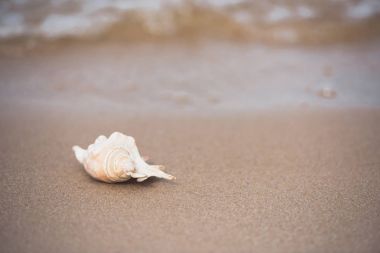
[[73, 132, 175, 183]]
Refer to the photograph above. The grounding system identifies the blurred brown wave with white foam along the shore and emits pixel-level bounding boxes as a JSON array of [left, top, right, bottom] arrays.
[[0, 0, 380, 46]]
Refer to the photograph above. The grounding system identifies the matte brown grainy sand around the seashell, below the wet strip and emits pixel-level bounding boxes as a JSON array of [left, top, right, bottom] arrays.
[[0, 104, 380, 252]]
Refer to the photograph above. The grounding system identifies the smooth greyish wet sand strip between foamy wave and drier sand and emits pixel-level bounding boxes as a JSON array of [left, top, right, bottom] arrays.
[[0, 40, 380, 110]]
